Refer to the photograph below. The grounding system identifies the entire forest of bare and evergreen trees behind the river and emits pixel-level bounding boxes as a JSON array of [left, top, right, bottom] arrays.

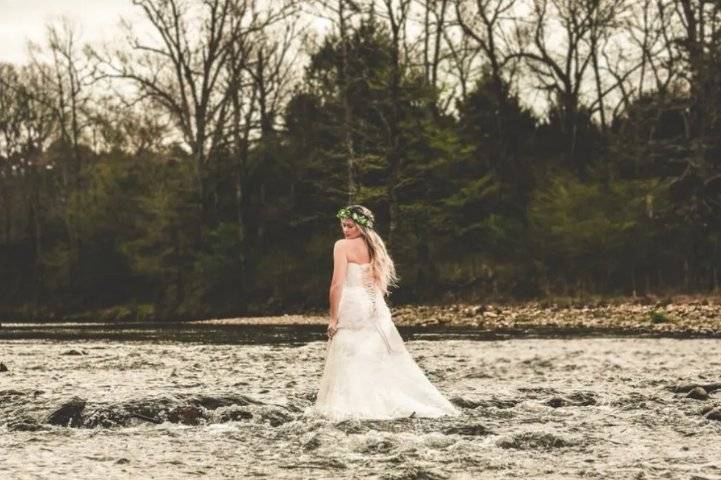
[[0, 0, 721, 320]]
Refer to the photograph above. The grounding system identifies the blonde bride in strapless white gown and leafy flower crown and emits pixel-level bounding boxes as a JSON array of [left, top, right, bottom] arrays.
[[310, 205, 460, 421]]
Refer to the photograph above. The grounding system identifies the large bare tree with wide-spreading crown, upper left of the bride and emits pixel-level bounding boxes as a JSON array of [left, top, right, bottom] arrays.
[[95, 0, 293, 220]]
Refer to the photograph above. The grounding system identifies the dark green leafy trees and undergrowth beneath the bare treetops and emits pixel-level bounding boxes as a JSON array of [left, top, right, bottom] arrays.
[[0, 10, 721, 322]]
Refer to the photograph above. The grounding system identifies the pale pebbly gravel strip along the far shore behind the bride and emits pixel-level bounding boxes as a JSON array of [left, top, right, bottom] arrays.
[[190, 296, 721, 337]]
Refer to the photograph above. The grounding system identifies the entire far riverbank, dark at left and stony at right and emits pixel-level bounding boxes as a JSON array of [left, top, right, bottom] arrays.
[[4, 295, 721, 337]]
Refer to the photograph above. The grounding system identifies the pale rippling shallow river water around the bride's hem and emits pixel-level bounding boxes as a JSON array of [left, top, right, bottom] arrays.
[[0, 327, 721, 480]]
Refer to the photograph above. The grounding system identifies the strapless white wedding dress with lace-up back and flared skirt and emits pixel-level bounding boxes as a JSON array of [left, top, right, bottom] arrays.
[[308, 262, 460, 421]]
